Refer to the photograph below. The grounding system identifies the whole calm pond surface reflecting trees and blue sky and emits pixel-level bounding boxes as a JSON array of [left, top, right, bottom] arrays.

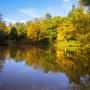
[[0, 46, 90, 90]]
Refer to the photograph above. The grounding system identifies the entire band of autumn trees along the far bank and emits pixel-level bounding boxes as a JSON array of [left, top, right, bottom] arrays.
[[0, 0, 90, 47]]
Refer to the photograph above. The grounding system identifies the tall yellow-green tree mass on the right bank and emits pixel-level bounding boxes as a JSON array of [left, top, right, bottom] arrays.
[[57, 7, 90, 46]]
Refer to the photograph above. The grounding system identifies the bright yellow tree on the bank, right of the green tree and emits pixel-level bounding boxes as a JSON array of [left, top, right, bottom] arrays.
[[57, 18, 76, 42]]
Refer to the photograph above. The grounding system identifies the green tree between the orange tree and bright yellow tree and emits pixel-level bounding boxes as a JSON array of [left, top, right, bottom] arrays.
[[42, 14, 60, 43]]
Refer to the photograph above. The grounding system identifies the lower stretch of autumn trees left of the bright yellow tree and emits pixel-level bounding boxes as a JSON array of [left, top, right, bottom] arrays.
[[0, 13, 61, 44]]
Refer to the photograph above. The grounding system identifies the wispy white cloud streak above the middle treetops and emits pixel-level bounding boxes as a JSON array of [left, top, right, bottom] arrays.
[[18, 6, 57, 18]]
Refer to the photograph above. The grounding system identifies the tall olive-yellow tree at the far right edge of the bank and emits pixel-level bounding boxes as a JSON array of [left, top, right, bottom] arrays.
[[69, 7, 90, 46]]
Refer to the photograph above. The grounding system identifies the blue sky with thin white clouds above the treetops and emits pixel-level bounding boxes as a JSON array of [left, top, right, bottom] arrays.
[[0, 0, 77, 23]]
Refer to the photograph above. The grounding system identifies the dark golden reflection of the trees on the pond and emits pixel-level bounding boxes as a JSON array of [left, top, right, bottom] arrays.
[[0, 46, 90, 90]]
